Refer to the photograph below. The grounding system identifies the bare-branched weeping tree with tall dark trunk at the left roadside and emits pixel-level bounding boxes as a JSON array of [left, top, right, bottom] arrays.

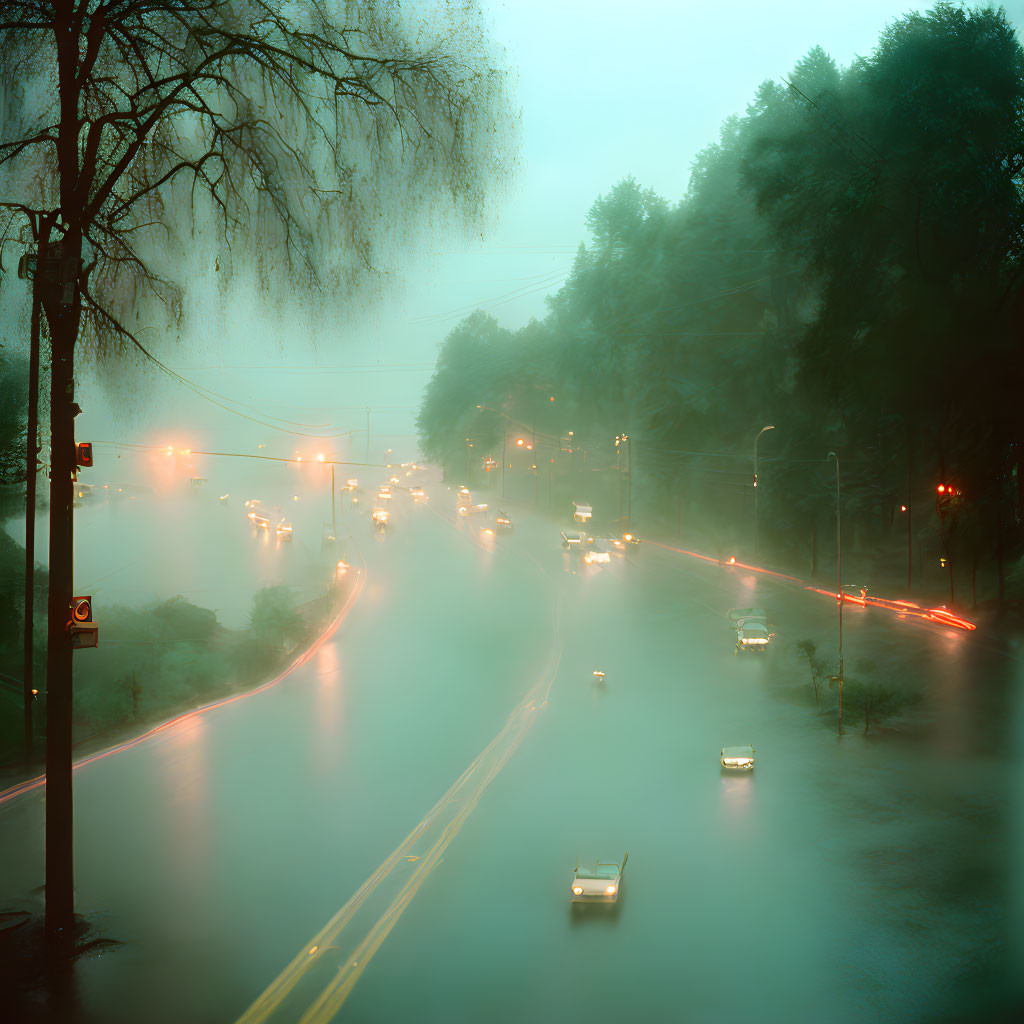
[[0, 0, 515, 937]]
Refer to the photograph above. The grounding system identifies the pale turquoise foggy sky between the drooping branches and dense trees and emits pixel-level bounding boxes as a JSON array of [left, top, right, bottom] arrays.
[[14, 0, 1024, 456]]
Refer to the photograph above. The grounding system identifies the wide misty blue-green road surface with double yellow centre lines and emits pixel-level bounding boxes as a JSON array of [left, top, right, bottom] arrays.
[[0, 473, 1024, 1022]]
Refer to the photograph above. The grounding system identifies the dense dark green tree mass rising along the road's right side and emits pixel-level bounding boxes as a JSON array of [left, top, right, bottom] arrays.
[[419, 4, 1024, 597]]
